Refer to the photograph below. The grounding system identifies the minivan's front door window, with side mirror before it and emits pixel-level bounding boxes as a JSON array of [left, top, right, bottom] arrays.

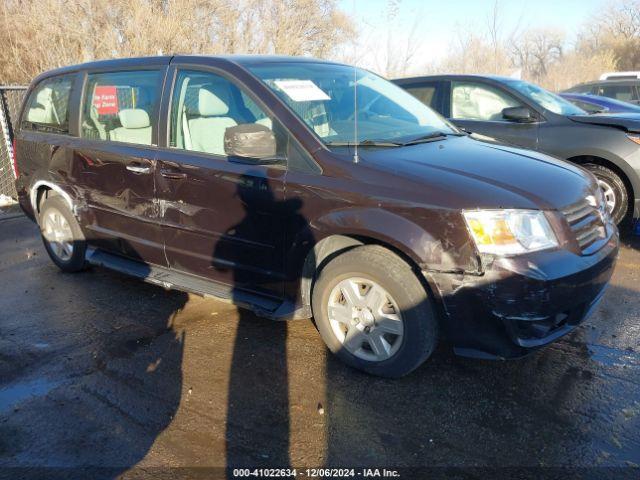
[[169, 70, 287, 159]]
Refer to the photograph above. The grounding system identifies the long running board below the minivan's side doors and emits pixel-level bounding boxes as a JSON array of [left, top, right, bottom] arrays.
[[86, 249, 309, 320]]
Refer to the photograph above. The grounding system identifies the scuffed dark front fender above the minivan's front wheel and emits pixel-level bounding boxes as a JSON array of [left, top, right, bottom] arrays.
[[286, 167, 480, 314]]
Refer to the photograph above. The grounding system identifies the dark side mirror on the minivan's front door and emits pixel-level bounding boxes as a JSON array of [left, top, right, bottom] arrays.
[[224, 123, 279, 163]]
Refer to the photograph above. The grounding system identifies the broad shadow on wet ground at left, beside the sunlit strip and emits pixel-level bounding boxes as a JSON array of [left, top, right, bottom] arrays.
[[0, 219, 188, 478]]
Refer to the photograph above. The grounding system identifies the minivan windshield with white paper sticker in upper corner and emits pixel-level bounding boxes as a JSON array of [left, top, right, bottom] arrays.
[[247, 62, 460, 146]]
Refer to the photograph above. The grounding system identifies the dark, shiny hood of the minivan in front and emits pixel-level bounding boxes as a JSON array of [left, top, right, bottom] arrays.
[[361, 137, 597, 210]]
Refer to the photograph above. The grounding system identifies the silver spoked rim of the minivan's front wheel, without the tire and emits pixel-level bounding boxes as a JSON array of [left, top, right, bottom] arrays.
[[327, 277, 404, 362]]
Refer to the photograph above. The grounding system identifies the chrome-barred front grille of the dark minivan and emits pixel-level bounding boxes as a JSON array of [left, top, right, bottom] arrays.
[[562, 196, 607, 255]]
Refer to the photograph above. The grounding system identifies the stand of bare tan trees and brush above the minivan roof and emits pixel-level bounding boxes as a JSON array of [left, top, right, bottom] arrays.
[[0, 0, 354, 83]]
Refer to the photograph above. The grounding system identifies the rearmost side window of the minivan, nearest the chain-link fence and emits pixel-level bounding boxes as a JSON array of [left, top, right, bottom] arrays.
[[22, 75, 73, 133]]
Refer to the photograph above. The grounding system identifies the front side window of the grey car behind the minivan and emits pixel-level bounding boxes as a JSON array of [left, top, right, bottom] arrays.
[[451, 82, 522, 122]]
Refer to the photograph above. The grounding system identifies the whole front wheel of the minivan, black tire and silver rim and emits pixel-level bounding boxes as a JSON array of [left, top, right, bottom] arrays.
[[312, 245, 438, 378]]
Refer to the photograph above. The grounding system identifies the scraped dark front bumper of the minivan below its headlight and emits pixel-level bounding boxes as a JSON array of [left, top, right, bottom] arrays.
[[424, 233, 619, 358]]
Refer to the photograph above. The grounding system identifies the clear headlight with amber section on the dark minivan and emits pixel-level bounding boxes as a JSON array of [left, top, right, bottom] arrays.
[[462, 210, 558, 255]]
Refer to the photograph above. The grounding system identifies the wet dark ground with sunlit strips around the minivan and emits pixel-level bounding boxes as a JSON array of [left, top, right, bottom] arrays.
[[0, 213, 640, 479]]
